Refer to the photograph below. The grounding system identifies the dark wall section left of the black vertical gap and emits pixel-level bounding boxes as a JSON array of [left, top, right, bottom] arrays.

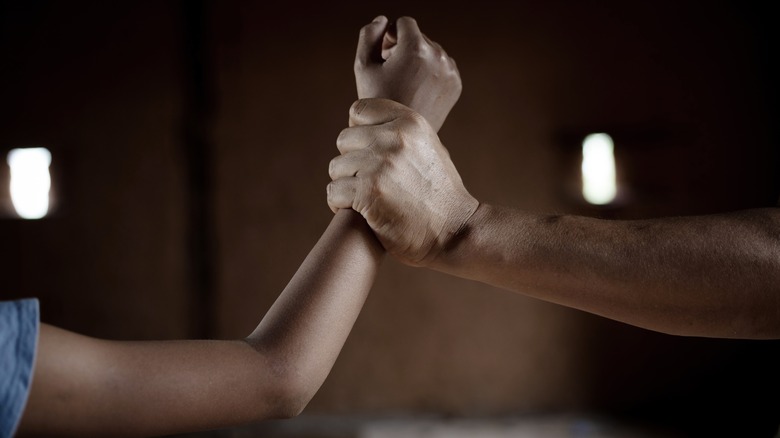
[[0, 1, 191, 338]]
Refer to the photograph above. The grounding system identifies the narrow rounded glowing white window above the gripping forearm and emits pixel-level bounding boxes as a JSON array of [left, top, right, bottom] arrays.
[[582, 133, 617, 205]]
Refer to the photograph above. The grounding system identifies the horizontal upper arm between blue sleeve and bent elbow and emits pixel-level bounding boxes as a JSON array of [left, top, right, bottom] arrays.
[[19, 324, 280, 437]]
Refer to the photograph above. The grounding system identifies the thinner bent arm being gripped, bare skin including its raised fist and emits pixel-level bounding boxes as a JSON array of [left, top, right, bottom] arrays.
[[18, 16, 461, 437]]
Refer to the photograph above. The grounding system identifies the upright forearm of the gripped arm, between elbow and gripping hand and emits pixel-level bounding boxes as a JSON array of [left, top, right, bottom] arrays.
[[241, 210, 384, 413]]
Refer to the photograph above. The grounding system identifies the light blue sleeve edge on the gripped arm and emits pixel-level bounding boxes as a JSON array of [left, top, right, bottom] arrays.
[[0, 298, 40, 438]]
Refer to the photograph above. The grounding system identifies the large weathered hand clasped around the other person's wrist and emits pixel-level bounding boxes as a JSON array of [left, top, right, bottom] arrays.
[[328, 98, 479, 266]]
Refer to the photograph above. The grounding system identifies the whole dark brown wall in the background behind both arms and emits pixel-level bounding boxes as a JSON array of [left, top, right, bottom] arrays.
[[0, 1, 780, 437]]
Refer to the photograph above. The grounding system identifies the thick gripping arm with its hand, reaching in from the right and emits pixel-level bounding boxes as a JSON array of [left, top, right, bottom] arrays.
[[328, 99, 780, 339]]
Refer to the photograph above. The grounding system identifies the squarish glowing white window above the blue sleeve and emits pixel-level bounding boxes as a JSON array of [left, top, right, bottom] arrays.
[[8, 147, 51, 219]]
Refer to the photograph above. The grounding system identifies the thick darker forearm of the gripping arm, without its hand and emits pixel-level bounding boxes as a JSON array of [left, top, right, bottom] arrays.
[[438, 205, 780, 339]]
